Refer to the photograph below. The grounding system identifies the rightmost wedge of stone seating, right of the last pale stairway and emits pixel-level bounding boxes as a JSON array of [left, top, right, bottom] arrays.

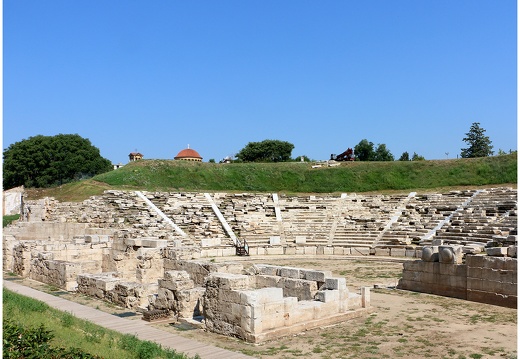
[[436, 188, 517, 244]]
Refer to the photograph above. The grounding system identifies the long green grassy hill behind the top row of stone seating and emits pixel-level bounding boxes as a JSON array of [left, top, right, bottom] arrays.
[[29, 153, 517, 201]]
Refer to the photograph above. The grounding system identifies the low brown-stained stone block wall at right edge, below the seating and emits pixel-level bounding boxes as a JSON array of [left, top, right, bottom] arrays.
[[397, 249, 518, 308]]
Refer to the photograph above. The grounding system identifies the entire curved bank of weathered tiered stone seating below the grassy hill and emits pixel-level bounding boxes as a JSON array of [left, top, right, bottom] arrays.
[[19, 188, 517, 255]]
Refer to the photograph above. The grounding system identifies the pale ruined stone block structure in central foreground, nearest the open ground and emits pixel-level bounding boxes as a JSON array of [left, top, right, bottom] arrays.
[[203, 265, 370, 343]]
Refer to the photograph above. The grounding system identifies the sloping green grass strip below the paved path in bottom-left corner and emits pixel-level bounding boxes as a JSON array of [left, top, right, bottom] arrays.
[[2, 288, 198, 359]]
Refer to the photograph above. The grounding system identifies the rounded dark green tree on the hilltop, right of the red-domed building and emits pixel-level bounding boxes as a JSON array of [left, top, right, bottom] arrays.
[[236, 140, 294, 162]]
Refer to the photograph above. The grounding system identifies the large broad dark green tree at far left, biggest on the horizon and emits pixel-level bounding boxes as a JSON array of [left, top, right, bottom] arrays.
[[3, 134, 112, 189]]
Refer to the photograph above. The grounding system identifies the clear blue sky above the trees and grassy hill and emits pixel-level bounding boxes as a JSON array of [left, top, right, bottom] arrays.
[[3, 0, 517, 163]]
